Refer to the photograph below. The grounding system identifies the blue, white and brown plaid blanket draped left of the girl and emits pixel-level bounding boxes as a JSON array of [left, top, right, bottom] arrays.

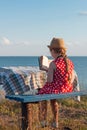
[[0, 67, 46, 95]]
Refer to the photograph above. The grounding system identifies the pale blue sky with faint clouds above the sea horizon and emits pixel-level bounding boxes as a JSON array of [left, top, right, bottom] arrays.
[[0, 0, 87, 56]]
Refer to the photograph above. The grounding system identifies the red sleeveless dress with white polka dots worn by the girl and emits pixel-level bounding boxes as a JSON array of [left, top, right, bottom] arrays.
[[38, 57, 74, 94]]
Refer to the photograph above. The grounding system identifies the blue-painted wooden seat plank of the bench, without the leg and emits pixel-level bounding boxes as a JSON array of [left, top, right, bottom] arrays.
[[6, 91, 87, 103]]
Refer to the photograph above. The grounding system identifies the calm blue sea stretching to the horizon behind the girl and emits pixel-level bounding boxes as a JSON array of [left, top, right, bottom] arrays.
[[0, 56, 87, 90]]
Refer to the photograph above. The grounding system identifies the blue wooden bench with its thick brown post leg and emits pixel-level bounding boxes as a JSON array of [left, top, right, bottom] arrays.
[[6, 91, 87, 130]]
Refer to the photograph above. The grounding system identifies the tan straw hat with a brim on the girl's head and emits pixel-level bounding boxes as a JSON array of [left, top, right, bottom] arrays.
[[47, 38, 66, 50]]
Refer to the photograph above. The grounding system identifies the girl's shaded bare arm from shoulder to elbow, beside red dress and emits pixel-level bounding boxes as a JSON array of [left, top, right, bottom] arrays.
[[47, 61, 56, 83]]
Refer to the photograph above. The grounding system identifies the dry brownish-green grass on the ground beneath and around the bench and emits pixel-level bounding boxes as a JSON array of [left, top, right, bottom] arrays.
[[0, 96, 87, 130]]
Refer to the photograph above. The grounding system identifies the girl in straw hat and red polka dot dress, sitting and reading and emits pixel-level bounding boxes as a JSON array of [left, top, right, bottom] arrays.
[[38, 38, 74, 128]]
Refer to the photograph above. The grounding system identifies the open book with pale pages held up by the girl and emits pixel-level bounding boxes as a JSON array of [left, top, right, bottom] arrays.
[[38, 56, 52, 71]]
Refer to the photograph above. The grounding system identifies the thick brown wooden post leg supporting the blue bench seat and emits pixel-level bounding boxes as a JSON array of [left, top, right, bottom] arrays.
[[21, 103, 32, 130]]
